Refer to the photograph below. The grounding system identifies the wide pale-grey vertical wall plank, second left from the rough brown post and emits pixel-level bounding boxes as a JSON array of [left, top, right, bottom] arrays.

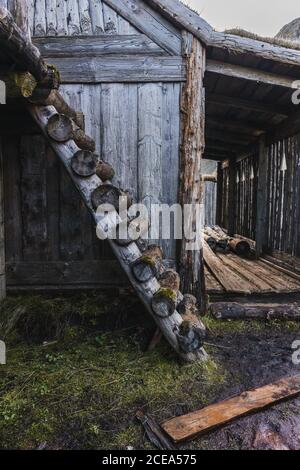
[[138, 83, 163, 248]]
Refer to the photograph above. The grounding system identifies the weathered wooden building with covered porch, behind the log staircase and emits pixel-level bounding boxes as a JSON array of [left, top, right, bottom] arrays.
[[0, 0, 300, 354]]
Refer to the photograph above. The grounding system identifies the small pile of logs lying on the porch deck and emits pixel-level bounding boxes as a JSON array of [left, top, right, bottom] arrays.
[[203, 225, 254, 258]]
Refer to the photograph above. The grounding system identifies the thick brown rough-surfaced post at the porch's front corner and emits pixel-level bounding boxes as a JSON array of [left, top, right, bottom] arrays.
[[180, 35, 206, 310]]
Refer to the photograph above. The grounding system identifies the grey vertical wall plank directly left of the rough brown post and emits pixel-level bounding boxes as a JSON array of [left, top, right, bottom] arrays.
[[162, 84, 181, 261]]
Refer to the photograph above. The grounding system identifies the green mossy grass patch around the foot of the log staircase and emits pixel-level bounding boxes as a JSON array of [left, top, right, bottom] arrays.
[[0, 295, 226, 449]]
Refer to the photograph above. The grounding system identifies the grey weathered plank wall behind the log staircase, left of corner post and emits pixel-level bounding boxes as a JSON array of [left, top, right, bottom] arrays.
[[0, 0, 184, 288]]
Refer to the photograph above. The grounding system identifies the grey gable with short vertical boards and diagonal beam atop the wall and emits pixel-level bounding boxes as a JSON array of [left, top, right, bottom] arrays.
[[29, 0, 181, 55]]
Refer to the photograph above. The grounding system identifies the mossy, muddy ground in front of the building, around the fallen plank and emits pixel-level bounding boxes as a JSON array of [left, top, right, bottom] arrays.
[[0, 293, 300, 450]]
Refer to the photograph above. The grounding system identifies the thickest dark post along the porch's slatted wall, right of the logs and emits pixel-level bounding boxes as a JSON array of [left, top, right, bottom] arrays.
[[255, 136, 268, 258]]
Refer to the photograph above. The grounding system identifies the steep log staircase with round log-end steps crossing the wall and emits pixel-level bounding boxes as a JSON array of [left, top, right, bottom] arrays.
[[0, 8, 207, 361]]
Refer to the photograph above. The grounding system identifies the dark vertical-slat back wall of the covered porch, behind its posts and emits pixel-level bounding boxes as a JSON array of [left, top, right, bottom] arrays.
[[222, 135, 300, 256]]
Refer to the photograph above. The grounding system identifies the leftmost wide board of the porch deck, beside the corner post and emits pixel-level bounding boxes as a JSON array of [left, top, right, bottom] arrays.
[[203, 240, 252, 294]]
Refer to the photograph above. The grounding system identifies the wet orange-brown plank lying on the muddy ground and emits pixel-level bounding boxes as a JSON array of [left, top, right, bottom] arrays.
[[162, 375, 300, 442]]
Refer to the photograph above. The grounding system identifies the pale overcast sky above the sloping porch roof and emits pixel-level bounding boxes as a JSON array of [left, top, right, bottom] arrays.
[[184, 0, 300, 36]]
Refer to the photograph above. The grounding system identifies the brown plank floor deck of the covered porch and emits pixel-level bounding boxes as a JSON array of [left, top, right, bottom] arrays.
[[204, 250, 300, 300]]
